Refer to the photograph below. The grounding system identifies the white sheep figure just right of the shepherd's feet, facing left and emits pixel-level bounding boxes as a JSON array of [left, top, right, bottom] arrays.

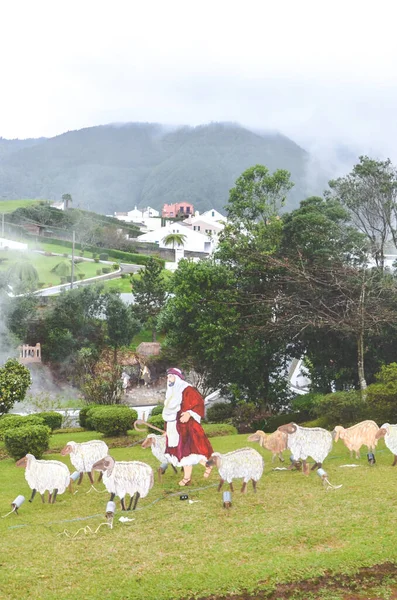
[[205, 448, 264, 494]]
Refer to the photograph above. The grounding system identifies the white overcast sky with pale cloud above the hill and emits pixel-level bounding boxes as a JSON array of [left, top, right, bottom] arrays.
[[0, 0, 397, 160]]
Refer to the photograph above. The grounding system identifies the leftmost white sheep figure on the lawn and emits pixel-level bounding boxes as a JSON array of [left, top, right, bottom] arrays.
[[16, 454, 70, 504]]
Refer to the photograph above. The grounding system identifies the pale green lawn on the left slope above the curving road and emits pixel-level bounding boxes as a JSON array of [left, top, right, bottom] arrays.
[[0, 250, 108, 287]]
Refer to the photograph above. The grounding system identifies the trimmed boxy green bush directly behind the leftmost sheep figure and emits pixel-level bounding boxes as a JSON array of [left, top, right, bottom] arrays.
[[4, 425, 51, 460]]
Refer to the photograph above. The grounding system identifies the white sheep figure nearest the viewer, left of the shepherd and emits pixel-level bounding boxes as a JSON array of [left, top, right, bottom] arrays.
[[92, 456, 154, 510]]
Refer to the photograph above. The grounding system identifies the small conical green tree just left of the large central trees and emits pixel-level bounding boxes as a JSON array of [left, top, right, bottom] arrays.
[[131, 258, 167, 342]]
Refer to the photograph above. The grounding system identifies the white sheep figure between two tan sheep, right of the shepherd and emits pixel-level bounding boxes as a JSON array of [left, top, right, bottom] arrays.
[[278, 423, 332, 475]]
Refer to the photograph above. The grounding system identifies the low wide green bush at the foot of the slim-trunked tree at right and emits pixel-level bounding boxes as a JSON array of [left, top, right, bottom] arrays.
[[314, 390, 368, 428]]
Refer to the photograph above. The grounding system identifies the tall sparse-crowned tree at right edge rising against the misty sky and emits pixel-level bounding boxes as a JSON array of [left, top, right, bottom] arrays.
[[329, 156, 397, 270]]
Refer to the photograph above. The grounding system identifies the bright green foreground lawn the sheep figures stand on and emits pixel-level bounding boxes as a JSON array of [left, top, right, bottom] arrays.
[[0, 432, 397, 600]]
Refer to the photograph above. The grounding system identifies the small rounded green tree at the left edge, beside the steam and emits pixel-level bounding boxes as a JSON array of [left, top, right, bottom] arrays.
[[0, 358, 32, 415]]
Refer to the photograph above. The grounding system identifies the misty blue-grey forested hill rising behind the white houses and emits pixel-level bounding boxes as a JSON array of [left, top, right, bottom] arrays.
[[0, 123, 321, 214]]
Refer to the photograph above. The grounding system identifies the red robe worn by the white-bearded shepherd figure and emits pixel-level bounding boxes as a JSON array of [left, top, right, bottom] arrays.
[[165, 386, 213, 461]]
